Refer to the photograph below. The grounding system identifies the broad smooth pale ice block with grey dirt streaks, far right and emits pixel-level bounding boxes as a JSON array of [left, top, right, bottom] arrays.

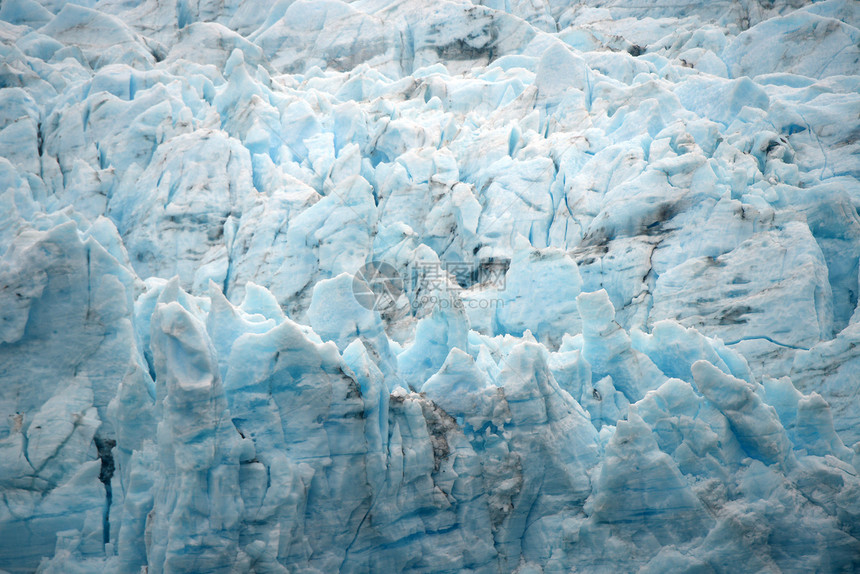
[[651, 223, 833, 348]]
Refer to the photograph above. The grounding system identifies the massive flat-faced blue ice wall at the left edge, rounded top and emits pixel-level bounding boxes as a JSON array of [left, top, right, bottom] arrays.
[[0, 214, 142, 570]]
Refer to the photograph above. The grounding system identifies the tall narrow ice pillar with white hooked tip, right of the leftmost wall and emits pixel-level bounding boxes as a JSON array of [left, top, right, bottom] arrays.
[[147, 291, 244, 572]]
